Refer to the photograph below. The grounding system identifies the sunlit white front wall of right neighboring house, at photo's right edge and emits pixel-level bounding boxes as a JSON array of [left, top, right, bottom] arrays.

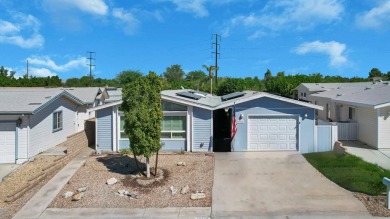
[[378, 107, 390, 149]]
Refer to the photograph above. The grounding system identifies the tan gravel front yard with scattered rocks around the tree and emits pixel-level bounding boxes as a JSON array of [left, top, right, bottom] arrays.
[[49, 153, 214, 208]]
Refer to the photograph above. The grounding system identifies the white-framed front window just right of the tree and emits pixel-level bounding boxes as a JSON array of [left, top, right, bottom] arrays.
[[161, 116, 186, 139]]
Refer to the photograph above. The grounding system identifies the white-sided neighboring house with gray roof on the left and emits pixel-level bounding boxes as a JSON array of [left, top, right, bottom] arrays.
[[0, 87, 108, 163]]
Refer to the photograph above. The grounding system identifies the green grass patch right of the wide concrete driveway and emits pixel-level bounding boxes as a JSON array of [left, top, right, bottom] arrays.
[[304, 152, 390, 195]]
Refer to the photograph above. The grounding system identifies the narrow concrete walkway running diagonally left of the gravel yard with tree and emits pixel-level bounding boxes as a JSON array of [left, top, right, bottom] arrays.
[[13, 148, 92, 219]]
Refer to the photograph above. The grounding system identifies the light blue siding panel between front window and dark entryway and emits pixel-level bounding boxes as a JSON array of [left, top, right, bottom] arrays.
[[192, 107, 213, 151]]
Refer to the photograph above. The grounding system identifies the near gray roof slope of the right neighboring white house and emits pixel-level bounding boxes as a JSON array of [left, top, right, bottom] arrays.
[[310, 81, 390, 109]]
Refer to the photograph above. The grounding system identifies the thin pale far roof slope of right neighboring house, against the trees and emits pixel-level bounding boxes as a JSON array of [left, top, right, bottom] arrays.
[[294, 81, 373, 92]]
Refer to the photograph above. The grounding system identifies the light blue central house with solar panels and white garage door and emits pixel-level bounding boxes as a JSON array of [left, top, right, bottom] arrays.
[[91, 90, 322, 153]]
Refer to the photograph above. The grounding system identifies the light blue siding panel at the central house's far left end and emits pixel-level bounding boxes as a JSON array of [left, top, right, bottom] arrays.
[[96, 107, 113, 151]]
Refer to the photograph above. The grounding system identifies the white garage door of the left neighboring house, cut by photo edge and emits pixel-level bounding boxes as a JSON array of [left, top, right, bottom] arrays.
[[0, 122, 16, 163]]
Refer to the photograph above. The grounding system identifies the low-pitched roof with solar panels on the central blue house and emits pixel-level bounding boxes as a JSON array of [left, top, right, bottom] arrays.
[[161, 90, 323, 110]]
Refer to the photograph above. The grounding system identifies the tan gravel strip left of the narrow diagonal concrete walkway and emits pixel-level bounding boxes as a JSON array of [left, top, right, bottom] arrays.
[[0, 155, 60, 219]]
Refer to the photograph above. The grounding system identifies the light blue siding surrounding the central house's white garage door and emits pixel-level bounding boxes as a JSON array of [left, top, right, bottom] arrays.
[[233, 97, 314, 153]]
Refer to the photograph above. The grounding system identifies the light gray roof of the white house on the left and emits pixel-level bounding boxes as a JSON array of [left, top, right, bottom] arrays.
[[0, 88, 85, 115]]
